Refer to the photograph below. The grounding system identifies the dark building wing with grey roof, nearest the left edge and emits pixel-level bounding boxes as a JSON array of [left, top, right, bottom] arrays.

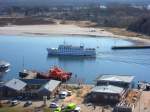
[[4, 79, 27, 97]]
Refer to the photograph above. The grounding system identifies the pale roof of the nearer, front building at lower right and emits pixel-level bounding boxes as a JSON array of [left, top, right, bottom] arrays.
[[92, 85, 124, 94]]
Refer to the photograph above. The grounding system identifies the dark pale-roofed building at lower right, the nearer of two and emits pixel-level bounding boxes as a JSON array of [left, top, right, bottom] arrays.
[[90, 85, 125, 104]]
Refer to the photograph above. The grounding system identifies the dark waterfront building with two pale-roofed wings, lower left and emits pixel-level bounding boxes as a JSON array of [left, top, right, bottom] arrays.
[[3, 79, 61, 99]]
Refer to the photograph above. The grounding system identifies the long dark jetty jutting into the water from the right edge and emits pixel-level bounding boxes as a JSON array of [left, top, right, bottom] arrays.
[[111, 45, 150, 50]]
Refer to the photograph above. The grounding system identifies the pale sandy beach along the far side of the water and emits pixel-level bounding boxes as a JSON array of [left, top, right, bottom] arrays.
[[0, 24, 150, 45]]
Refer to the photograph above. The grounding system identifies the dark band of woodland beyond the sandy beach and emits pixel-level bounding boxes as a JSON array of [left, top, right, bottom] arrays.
[[0, 4, 150, 35]]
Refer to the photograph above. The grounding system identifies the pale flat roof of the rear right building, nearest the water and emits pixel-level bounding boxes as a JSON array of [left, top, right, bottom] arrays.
[[96, 74, 134, 83]]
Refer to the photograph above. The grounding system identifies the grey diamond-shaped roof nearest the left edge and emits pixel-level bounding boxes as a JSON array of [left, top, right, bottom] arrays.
[[5, 79, 27, 91]]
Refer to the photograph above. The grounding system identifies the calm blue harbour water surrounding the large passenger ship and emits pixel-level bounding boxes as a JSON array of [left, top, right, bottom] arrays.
[[0, 35, 150, 83]]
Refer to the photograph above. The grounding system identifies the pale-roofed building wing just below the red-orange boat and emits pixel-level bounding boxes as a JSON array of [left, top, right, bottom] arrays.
[[38, 80, 61, 98]]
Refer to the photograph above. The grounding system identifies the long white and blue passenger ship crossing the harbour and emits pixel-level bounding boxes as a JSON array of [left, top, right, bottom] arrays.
[[47, 44, 96, 57]]
